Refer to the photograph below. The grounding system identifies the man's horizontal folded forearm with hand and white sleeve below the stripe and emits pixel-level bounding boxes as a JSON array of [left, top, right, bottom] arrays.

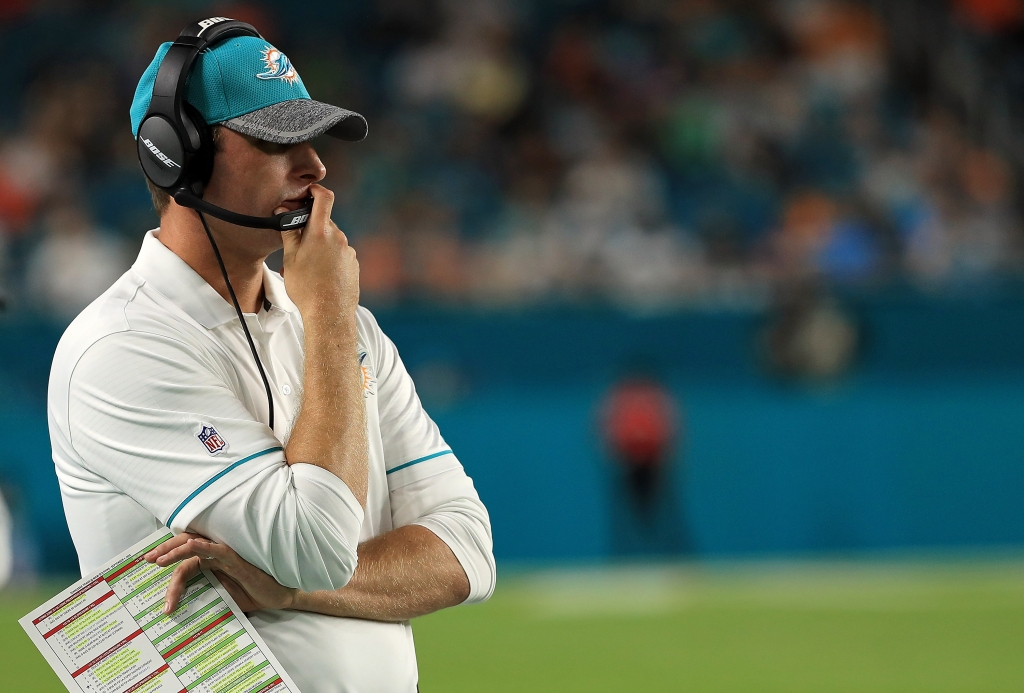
[[156, 463, 495, 621]]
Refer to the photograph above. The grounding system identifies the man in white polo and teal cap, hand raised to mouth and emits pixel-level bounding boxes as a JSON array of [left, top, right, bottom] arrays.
[[49, 26, 495, 693]]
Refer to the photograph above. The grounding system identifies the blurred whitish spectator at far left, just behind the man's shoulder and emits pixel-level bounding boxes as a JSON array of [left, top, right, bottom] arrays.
[[26, 202, 130, 319]]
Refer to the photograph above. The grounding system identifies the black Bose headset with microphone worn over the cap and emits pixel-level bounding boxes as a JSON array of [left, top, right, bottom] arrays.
[[136, 16, 312, 231]]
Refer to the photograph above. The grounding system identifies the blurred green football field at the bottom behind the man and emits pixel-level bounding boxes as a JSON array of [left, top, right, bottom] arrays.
[[0, 560, 1024, 693]]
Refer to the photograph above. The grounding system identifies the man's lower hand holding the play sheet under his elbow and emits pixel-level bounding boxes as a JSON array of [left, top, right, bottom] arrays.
[[143, 532, 298, 614]]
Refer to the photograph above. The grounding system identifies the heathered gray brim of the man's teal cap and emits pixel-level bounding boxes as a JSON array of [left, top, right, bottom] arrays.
[[221, 98, 367, 144]]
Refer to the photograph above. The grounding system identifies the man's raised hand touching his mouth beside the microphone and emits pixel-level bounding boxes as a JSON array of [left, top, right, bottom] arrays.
[[274, 183, 359, 323]]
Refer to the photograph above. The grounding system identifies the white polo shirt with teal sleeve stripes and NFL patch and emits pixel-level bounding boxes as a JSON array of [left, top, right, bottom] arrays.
[[48, 229, 495, 693]]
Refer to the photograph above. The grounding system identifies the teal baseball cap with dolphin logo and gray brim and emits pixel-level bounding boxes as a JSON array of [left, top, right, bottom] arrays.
[[131, 36, 367, 144]]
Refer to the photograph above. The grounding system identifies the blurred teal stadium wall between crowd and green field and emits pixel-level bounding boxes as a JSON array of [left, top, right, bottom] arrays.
[[6, 295, 1024, 570]]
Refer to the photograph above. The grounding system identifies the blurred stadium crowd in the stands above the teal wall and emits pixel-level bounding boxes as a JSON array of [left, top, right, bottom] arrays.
[[0, 0, 1024, 318]]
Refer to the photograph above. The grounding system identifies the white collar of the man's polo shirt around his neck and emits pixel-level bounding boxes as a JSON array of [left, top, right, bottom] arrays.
[[132, 229, 296, 330]]
